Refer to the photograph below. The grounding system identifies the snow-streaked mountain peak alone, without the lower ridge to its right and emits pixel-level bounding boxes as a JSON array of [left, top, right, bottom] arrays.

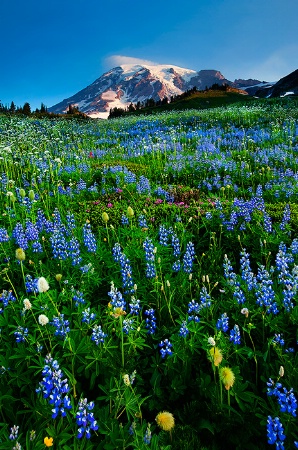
[[48, 64, 231, 118]]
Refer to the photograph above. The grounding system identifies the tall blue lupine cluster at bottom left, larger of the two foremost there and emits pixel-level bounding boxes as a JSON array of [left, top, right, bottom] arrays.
[[36, 354, 72, 419]]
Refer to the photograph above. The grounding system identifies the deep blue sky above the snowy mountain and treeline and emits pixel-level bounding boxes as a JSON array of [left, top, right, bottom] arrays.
[[0, 0, 298, 109]]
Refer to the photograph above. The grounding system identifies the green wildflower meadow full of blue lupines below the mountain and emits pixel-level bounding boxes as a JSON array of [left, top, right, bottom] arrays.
[[0, 98, 298, 450]]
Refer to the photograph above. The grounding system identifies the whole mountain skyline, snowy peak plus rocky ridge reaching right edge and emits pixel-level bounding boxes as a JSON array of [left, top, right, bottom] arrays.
[[48, 64, 298, 118]]
